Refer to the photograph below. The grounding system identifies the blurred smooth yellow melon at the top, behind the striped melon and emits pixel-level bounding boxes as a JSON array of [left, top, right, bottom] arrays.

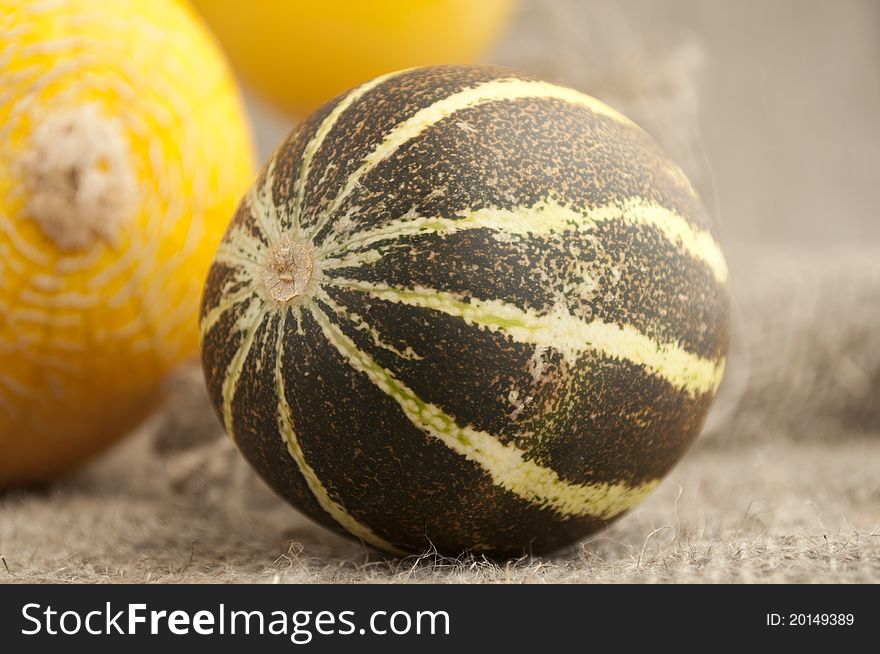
[[194, 0, 513, 117]]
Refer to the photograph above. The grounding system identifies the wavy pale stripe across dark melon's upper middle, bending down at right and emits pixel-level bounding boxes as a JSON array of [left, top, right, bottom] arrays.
[[320, 198, 727, 284]]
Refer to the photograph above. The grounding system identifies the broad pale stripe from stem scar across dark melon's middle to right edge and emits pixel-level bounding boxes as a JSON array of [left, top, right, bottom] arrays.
[[328, 279, 724, 395]]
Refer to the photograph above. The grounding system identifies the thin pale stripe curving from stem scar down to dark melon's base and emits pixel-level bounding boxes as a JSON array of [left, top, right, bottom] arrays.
[[275, 311, 406, 556]]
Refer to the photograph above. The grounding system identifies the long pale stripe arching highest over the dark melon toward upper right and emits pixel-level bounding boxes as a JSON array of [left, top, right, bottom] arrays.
[[320, 78, 636, 231]]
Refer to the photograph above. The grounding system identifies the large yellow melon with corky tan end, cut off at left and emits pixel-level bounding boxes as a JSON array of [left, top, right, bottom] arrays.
[[0, 0, 253, 488]]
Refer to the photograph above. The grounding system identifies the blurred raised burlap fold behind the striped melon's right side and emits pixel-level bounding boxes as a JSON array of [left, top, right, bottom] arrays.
[[704, 246, 880, 446]]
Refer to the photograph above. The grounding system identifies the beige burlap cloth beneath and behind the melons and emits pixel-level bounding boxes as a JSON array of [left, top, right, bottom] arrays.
[[0, 0, 880, 583]]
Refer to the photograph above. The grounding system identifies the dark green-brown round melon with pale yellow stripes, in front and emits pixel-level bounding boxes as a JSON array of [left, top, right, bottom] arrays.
[[201, 66, 728, 556]]
